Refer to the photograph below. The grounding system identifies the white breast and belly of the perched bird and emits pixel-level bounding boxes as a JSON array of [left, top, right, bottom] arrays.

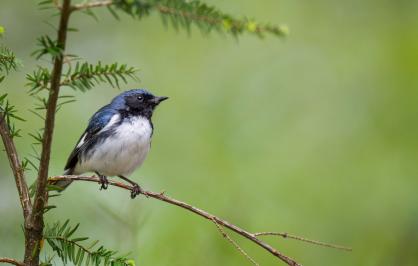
[[75, 115, 152, 177]]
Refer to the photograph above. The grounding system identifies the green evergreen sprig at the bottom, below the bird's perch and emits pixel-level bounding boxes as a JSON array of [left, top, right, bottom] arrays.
[[44, 220, 135, 266]]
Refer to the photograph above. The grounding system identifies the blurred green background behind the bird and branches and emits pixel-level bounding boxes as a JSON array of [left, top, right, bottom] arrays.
[[0, 0, 418, 265]]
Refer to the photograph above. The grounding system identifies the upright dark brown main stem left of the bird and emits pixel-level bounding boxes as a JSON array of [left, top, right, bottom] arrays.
[[25, 0, 71, 266]]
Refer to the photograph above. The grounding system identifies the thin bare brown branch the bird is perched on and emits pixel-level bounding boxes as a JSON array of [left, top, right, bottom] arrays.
[[48, 176, 300, 266]]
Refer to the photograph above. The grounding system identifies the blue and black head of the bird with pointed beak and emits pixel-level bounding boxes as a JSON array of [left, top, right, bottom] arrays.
[[112, 89, 168, 118]]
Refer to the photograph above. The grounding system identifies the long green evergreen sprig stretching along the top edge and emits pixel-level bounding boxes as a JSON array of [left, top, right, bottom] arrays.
[[109, 0, 288, 37]]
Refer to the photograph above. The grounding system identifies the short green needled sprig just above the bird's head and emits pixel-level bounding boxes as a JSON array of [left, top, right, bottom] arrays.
[[61, 62, 138, 91]]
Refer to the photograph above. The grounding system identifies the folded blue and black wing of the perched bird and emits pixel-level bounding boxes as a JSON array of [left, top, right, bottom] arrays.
[[64, 105, 117, 172]]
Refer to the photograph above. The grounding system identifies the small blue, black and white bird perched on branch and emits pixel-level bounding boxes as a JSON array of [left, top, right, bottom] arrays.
[[54, 89, 168, 198]]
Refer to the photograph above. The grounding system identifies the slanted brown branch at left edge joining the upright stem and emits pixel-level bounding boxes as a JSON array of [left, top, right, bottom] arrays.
[[0, 110, 32, 218]]
